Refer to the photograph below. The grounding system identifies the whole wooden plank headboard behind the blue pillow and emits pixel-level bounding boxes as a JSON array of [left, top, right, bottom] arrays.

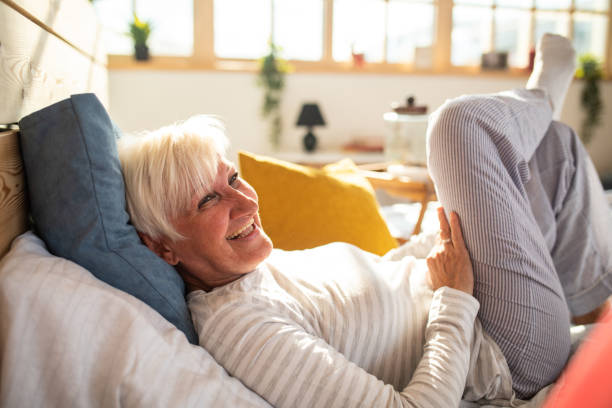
[[0, 0, 108, 257]]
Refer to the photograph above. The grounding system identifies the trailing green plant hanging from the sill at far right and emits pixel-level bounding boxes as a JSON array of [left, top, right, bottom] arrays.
[[576, 54, 603, 145]]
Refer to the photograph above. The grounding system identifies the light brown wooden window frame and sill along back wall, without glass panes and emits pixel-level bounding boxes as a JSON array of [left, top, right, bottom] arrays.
[[108, 0, 612, 79]]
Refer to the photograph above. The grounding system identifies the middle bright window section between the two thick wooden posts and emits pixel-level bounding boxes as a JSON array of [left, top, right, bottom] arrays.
[[214, 0, 434, 63]]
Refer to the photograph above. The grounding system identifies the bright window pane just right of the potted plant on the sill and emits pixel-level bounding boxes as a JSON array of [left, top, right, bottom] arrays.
[[137, 0, 193, 55]]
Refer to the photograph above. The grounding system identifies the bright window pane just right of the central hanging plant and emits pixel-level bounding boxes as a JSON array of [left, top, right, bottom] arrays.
[[274, 0, 323, 60]]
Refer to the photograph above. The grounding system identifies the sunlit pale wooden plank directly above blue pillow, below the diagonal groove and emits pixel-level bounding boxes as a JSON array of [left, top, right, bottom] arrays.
[[0, 0, 108, 124]]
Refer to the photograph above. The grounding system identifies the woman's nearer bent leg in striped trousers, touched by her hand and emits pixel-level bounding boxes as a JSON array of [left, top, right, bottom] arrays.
[[428, 90, 570, 397]]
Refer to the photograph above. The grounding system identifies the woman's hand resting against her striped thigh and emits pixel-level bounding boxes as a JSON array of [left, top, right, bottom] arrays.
[[427, 207, 474, 295]]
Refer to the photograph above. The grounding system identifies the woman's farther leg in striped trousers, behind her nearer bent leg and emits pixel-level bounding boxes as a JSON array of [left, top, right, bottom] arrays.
[[526, 122, 612, 317]]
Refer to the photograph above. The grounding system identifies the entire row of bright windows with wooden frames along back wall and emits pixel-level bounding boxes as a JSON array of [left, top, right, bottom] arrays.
[[94, 0, 612, 75]]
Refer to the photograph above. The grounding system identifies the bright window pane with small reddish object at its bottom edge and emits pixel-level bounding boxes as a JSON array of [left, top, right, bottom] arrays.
[[332, 0, 385, 62]]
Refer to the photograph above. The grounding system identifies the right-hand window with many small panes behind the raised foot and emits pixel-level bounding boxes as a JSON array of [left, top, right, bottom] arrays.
[[451, 0, 609, 68]]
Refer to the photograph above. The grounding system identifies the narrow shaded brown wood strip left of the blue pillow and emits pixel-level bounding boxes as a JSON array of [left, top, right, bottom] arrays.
[[0, 130, 27, 258]]
